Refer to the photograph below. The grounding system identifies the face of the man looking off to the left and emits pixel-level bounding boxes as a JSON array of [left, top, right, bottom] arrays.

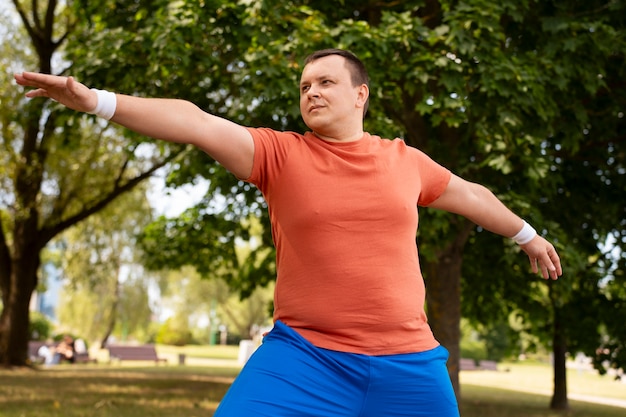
[[300, 55, 367, 139]]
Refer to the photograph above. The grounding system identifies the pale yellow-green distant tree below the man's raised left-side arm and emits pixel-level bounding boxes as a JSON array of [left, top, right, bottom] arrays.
[[58, 186, 152, 348]]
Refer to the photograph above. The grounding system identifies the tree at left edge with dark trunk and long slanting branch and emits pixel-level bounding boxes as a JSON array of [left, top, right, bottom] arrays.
[[0, 0, 182, 366]]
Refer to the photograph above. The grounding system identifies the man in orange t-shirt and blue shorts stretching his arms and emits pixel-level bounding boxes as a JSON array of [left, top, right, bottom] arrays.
[[15, 49, 562, 417]]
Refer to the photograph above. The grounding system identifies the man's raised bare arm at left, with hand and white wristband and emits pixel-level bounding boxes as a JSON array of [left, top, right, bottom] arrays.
[[15, 72, 254, 179]]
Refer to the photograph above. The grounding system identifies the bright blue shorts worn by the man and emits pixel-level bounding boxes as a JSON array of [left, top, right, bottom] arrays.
[[214, 322, 459, 417]]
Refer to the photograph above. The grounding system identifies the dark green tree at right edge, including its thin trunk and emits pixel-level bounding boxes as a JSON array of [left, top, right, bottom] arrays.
[[464, 2, 626, 400]]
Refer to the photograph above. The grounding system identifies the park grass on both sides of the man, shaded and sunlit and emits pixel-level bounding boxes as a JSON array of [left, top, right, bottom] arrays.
[[0, 358, 626, 417]]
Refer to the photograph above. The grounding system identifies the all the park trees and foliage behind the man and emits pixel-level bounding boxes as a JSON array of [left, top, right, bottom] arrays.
[[0, 0, 626, 409]]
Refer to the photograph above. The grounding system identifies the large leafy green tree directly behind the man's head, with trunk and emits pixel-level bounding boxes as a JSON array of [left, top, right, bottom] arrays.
[[130, 0, 623, 400]]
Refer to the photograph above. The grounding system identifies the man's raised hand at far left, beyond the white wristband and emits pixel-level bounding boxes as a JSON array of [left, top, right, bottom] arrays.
[[14, 72, 98, 112]]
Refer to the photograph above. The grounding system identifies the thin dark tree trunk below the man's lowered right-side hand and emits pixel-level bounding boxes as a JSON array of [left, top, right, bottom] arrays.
[[550, 285, 569, 410]]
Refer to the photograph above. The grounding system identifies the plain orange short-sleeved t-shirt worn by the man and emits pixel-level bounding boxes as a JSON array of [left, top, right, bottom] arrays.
[[247, 129, 450, 355]]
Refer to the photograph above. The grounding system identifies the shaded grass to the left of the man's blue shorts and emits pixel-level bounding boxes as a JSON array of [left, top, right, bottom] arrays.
[[0, 366, 236, 417]]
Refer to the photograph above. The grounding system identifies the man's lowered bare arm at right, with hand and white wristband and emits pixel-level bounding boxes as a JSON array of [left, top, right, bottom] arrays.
[[429, 175, 563, 279]]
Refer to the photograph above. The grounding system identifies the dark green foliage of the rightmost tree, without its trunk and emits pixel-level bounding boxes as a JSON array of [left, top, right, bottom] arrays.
[[456, 2, 626, 374]]
